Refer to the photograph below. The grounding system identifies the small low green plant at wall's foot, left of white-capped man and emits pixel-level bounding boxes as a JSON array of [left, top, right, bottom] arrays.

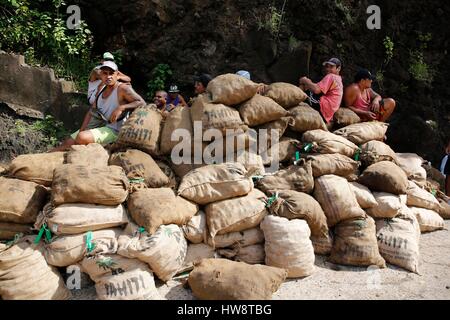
[[15, 115, 68, 148]]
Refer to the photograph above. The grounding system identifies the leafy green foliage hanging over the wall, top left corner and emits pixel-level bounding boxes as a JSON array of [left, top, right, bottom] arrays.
[[0, 0, 93, 90]]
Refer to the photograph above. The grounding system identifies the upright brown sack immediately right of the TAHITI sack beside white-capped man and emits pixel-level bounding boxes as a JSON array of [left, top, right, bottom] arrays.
[[160, 107, 194, 155]]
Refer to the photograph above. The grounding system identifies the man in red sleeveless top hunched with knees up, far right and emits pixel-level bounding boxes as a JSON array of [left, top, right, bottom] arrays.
[[345, 69, 396, 122]]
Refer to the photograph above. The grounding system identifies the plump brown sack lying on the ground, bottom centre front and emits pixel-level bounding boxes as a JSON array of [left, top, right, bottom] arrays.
[[188, 259, 287, 300]]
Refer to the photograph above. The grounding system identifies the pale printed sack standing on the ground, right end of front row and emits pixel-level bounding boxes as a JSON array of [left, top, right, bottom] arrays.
[[376, 208, 420, 273]]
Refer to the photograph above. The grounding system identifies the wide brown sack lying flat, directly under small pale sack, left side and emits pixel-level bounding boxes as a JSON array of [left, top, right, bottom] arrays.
[[52, 164, 129, 206]]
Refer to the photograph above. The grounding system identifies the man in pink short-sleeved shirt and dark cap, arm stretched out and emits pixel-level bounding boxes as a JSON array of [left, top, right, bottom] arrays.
[[300, 58, 344, 124]]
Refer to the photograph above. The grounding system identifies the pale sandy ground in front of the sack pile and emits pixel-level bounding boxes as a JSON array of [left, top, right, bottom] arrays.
[[72, 221, 450, 300]]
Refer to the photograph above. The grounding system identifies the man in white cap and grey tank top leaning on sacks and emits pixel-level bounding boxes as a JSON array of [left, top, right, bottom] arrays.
[[52, 61, 145, 152]]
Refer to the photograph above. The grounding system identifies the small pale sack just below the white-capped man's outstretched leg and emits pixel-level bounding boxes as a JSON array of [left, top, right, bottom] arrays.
[[67, 143, 109, 167]]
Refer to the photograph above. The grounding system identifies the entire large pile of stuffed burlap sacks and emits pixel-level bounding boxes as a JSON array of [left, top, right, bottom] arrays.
[[0, 74, 450, 300]]
